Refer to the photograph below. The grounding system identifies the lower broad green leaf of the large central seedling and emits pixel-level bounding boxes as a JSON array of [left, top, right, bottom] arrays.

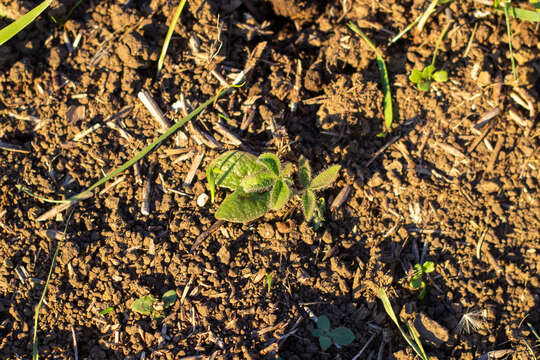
[[216, 189, 270, 223]]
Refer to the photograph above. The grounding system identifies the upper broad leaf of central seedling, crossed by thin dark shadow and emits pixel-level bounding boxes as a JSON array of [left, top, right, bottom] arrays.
[[207, 150, 266, 190]]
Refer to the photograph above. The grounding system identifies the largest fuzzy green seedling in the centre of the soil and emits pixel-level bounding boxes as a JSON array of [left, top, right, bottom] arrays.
[[206, 150, 341, 223]]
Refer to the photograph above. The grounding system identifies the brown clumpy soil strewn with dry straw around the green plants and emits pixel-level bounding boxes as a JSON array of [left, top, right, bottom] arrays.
[[0, 0, 540, 360]]
